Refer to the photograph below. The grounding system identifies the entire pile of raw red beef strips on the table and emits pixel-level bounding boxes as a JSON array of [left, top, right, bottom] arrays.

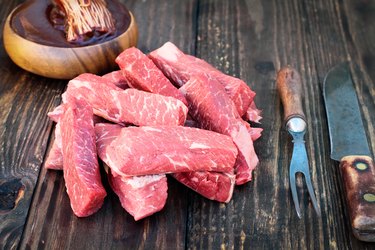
[[45, 42, 261, 220]]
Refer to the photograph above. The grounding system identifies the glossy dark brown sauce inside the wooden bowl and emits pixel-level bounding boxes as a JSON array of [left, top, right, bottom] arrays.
[[11, 0, 130, 47]]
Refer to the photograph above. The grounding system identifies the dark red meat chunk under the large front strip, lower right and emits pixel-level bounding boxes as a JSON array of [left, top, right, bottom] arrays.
[[172, 171, 236, 202]]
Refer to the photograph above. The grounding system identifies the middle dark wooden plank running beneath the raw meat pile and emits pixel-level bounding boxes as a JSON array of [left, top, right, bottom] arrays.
[[16, 0, 197, 249]]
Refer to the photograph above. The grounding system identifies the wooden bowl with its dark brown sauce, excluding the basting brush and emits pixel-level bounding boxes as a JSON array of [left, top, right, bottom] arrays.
[[3, 0, 138, 79]]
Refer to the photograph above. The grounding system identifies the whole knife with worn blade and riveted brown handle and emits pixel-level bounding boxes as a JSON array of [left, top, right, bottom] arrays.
[[323, 63, 375, 242]]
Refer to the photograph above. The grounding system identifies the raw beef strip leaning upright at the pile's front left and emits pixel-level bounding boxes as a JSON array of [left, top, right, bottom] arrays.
[[60, 99, 106, 217]]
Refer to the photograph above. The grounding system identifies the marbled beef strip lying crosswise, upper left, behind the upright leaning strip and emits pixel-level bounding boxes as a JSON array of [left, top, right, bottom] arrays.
[[62, 73, 191, 126]]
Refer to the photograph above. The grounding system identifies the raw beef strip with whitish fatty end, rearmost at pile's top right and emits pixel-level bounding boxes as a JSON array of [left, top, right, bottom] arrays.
[[149, 42, 259, 119]]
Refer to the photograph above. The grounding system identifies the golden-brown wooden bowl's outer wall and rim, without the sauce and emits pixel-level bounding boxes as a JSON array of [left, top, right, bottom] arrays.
[[3, 5, 138, 79]]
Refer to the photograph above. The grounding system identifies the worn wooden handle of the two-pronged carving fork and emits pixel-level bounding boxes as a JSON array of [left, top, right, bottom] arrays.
[[276, 66, 306, 122]]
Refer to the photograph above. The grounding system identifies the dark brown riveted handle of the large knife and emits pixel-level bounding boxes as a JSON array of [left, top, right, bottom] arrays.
[[340, 155, 375, 242]]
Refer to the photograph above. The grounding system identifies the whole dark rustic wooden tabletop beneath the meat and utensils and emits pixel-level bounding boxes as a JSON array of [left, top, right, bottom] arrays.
[[0, 0, 375, 249]]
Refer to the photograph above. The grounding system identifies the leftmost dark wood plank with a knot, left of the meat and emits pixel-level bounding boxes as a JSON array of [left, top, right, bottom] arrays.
[[0, 1, 64, 249]]
